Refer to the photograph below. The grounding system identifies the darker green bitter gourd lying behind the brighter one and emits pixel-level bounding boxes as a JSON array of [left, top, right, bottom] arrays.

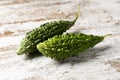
[[17, 6, 79, 55]]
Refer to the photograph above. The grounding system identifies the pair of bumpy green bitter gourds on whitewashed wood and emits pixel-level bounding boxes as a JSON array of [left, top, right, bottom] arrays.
[[17, 5, 109, 60]]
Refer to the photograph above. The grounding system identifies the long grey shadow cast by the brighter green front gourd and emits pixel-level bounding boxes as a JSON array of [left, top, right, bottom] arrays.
[[58, 46, 112, 65]]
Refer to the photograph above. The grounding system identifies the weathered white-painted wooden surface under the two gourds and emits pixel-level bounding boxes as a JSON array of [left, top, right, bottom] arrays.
[[0, 0, 120, 80]]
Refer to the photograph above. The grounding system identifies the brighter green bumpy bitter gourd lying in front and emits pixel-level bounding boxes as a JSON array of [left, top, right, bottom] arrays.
[[37, 33, 108, 61]]
